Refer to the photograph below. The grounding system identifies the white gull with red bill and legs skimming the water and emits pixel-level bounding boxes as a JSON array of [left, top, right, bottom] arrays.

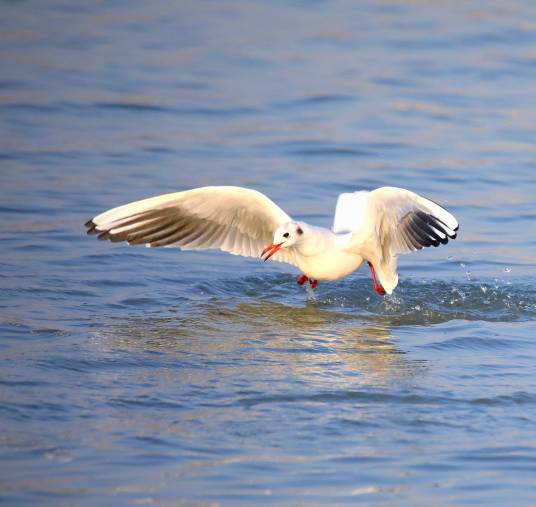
[[85, 186, 459, 296]]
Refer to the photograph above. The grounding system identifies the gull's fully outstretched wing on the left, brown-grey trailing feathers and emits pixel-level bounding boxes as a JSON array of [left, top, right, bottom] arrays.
[[86, 186, 295, 264]]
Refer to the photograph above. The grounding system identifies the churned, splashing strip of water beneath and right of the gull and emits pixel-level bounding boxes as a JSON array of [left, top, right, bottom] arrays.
[[223, 275, 536, 325]]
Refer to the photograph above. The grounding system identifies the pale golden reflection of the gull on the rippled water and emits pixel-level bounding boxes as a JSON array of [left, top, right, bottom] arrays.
[[93, 301, 425, 384]]
